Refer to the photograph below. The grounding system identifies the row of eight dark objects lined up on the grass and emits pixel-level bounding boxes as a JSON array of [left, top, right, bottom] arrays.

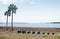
[[17, 30, 55, 35]]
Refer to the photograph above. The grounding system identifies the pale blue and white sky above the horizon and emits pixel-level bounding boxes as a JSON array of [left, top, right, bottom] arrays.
[[0, 0, 60, 23]]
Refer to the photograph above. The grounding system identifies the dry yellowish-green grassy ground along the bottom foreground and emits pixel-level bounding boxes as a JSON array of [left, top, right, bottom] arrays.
[[0, 31, 60, 39]]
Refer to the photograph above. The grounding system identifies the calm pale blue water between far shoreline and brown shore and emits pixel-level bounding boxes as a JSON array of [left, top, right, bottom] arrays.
[[0, 23, 60, 28]]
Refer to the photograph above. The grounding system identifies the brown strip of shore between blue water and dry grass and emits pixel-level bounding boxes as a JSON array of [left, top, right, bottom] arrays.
[[0, 26, 60, 32]]
